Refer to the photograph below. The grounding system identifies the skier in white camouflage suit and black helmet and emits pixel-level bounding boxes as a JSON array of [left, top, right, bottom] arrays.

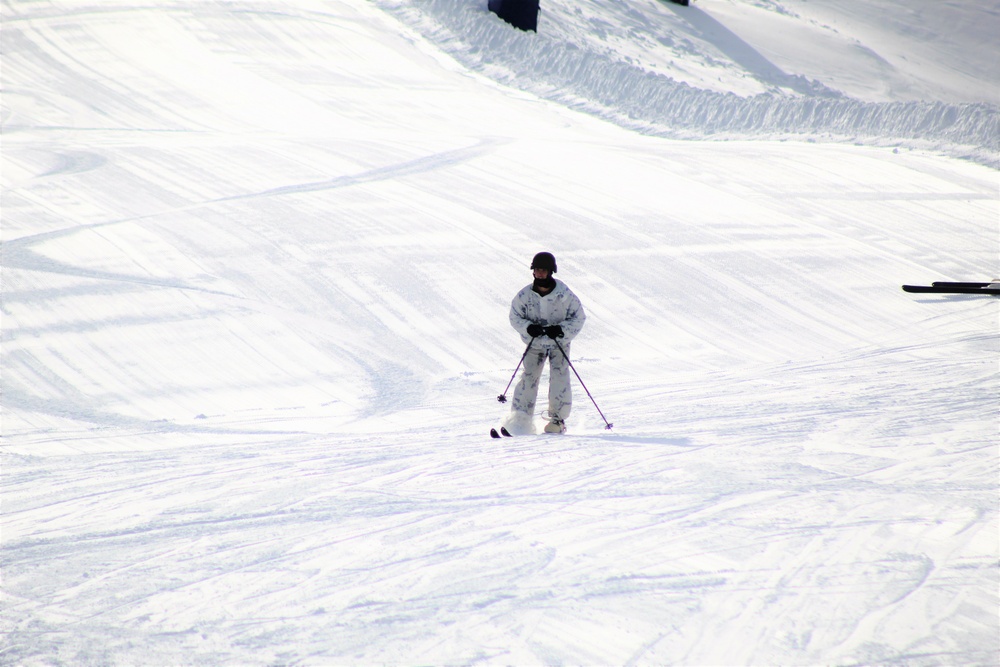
[[504, 252, 587, 434]]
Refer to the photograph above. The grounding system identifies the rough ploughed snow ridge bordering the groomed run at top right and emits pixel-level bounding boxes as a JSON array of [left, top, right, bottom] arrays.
[[377, 0, 1000, 166]]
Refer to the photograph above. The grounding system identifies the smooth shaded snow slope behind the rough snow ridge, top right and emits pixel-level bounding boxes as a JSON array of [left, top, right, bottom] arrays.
[[379, 0, 1000, 105]]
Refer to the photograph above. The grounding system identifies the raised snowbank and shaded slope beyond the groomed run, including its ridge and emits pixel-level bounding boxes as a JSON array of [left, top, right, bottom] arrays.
[[378, 0, 1000, 166]]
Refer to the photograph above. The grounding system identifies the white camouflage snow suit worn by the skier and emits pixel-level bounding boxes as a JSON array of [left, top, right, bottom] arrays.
[[505, 280, 587, 433]]
